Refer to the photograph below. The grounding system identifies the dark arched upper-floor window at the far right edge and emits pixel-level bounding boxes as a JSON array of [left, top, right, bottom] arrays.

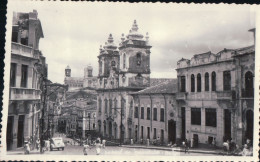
[[245, 71, 254, 97]]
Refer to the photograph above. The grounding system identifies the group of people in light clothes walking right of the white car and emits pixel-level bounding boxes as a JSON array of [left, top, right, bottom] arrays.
[[83, 137, 106, 155]]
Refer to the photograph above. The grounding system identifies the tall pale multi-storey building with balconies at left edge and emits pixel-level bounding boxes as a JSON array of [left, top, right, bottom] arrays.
[[6, 10, 47, 150]]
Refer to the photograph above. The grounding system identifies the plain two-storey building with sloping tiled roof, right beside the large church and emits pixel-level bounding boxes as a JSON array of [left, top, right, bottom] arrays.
[[129, 79, 179, 144]]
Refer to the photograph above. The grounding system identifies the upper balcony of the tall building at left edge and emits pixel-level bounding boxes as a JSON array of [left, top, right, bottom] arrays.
[[12, 42, 40, 59]]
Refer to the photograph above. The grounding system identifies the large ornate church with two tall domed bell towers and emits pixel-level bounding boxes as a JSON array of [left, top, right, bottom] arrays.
[[97, 21, 151, 141]]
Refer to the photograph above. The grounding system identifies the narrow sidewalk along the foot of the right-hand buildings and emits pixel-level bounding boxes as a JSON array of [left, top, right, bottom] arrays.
[[122, 144, 222, 155]]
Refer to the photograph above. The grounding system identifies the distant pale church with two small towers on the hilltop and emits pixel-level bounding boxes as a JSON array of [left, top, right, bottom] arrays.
[[64, 65, 97, 91]]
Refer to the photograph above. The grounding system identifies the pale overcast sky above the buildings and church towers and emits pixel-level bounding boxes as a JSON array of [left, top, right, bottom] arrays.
[[8, 1, 255, 83]]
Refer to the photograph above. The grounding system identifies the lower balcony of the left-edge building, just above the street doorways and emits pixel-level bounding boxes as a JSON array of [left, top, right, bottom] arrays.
[[9, 87, 41, 100]]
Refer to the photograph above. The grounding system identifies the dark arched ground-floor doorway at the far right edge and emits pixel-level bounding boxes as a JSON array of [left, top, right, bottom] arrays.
[[245, 110, 254, 140]]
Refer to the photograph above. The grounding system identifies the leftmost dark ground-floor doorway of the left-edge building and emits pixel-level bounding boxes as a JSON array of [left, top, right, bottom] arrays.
[[6, 116, 14, 151]]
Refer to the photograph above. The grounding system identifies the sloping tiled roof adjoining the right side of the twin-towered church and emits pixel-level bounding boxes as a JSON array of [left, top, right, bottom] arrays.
[[132, 79, 178, 95]]
